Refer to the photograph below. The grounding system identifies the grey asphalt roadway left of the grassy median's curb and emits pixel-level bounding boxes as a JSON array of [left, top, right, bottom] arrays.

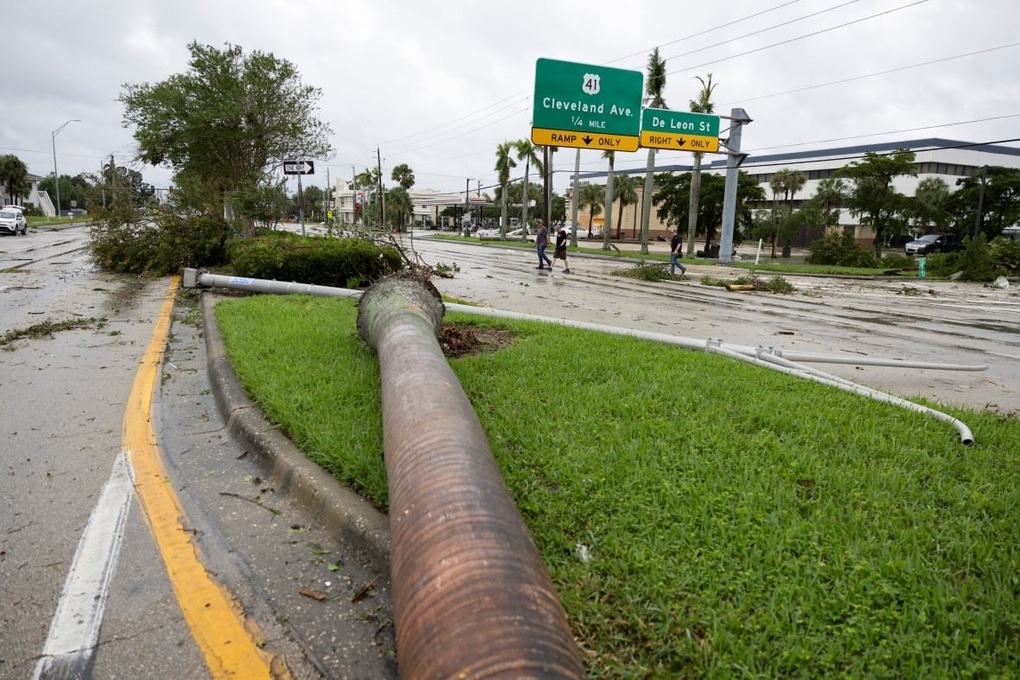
[[0, 227, 396, 678]]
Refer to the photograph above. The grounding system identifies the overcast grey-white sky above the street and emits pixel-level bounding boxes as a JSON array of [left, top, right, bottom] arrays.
[[0, 0, 1020, 199]]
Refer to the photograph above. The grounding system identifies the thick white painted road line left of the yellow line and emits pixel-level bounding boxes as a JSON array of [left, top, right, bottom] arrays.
[[32, 452, 135, 680]]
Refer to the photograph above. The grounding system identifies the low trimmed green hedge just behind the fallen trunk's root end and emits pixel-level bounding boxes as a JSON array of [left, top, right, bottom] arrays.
[[228, 232, 403, 287]]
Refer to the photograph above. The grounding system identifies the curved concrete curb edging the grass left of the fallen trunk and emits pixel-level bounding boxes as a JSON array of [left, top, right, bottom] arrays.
[[202, 291, 390, 573]]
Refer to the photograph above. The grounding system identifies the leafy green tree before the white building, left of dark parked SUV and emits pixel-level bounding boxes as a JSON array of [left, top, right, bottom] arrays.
[[838, 149, 917, 257]]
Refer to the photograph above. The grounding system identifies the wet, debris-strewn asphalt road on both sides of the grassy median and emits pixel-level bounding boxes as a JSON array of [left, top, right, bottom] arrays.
[[0, 227, 1020, 678]]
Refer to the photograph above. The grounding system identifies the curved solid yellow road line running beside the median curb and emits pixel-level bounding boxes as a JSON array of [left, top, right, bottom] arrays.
[[123, 276, 273, 680]]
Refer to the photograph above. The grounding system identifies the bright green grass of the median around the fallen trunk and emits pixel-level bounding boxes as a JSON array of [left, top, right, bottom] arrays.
[[216, 296, 1020, 678]]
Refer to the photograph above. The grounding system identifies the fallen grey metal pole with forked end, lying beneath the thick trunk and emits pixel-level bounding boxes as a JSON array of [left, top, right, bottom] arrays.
[[183, 268, 988, 446]]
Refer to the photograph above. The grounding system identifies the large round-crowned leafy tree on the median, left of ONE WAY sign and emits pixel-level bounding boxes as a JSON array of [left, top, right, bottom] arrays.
[[119, 42, 333, 235]]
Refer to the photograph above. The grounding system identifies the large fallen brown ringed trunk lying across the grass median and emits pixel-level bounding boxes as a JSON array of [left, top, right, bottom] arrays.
[[358, 277, 584, 679]]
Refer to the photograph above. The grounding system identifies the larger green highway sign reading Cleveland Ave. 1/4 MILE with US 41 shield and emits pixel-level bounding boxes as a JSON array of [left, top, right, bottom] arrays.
[[531, 59, 645, 151]]
